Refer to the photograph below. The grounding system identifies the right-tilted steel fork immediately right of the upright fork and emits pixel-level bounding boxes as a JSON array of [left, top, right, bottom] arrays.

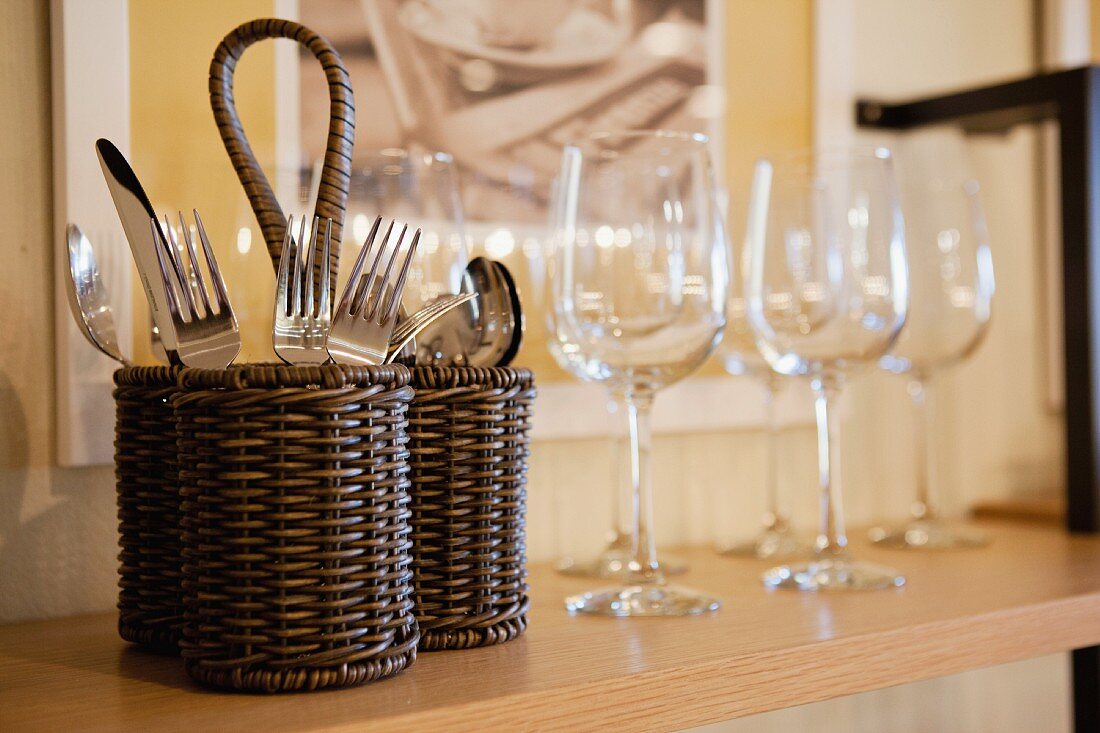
[[328, 217, 420, 364]]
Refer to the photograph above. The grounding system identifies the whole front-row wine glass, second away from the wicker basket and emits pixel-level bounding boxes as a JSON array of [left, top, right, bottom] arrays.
[[746, 147, 909, 590]]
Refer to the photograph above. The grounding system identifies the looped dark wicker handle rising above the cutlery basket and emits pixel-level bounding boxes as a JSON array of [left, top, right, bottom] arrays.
[[210, 18, 355, 287]]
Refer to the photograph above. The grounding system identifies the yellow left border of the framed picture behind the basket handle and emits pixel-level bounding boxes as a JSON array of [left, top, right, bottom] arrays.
[[130, 0, 282, 363]]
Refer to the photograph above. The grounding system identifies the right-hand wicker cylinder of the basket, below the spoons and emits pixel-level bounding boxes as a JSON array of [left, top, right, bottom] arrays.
[[409, 367, 535, 652]]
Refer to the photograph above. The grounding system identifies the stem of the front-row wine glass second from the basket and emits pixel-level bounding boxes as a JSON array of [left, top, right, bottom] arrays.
[[811, 376, 848, 559]]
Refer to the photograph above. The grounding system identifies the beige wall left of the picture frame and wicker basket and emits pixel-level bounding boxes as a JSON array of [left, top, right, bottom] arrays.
[[0, 2, 118, 621]]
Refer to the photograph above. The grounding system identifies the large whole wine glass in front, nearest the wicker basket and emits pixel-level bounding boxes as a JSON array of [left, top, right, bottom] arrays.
[[548, 131, 729, 616]]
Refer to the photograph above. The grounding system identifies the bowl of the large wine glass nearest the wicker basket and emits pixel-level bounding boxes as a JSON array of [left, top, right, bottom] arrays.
[[554, 133, 726, 390]]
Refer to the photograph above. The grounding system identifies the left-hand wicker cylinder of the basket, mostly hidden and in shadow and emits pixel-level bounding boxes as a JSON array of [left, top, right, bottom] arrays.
[[114, 367, 184, 654]]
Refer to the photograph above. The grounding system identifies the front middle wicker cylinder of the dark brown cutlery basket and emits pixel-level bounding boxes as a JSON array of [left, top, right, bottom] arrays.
[[173, 365, 419, 692]]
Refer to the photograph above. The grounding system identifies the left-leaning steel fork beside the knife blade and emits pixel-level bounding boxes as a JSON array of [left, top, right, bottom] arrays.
[[150, 209, 241, 369]]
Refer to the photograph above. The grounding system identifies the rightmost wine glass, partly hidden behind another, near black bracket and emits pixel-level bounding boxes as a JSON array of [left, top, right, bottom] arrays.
[[870, 133, 993, 549]]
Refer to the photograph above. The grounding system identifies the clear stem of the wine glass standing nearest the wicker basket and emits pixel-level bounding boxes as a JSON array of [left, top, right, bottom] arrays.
[[626, 387, 664, 584]]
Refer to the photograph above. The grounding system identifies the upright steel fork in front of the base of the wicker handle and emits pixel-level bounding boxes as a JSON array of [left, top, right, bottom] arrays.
[[272, 216, 332, 367]]
